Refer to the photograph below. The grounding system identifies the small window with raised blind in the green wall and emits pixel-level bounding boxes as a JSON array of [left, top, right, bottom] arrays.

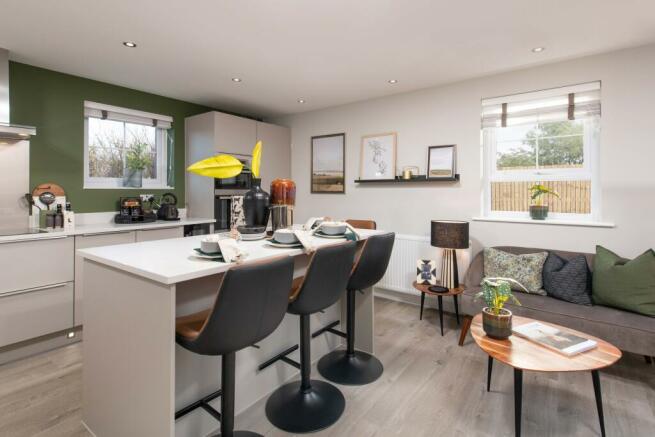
[[84, 102, 174, 188]]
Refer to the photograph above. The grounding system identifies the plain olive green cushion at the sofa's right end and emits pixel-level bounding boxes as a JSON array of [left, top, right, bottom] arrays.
[[592, 246, 655, 317]]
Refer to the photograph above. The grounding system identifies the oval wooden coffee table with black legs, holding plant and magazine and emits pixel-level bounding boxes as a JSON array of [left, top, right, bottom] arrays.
[[471, 314, 621, 437]]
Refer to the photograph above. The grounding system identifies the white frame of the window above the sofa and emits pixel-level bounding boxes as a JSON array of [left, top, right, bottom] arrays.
[[480, 93, 601, 222]]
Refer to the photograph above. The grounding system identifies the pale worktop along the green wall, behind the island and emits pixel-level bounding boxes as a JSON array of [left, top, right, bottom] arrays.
[[0, 217, 215, 243]]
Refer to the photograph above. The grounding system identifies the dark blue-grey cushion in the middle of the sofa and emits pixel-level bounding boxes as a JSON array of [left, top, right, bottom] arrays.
[[544, 253, 592, 305]]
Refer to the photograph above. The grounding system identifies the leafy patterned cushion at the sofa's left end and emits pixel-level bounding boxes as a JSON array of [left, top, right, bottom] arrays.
[[484, 247, 548, 296]]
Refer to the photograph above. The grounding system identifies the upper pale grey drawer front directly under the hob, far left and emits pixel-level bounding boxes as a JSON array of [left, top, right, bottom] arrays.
[[0, 236, 74, 294]]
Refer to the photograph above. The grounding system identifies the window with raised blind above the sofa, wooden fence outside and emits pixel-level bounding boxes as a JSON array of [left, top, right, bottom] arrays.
[[482, 82, 600, 220]]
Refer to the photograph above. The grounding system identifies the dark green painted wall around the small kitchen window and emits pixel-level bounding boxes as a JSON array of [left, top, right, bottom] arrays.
[[9, 62, 213, 212]]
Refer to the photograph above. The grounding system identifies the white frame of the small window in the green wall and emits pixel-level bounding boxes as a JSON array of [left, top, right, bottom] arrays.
[[83, 102, 175, 190]]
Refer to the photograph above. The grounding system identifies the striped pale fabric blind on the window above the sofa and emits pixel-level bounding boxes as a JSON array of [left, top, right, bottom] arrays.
[[482, 82, 600, 128]]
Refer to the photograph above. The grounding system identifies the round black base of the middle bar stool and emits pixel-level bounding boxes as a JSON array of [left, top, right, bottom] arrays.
[[266, 379, 346, 433]]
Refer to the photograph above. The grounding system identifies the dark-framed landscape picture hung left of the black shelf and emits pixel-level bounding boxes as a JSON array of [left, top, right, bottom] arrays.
[[311, 133, 346, 194]]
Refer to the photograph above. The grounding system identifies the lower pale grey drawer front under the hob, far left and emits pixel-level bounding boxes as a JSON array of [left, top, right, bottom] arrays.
[[0, 282, 73, 347]]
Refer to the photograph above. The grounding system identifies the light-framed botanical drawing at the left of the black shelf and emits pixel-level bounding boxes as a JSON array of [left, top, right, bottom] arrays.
[[359, 132, 396, 179]]
